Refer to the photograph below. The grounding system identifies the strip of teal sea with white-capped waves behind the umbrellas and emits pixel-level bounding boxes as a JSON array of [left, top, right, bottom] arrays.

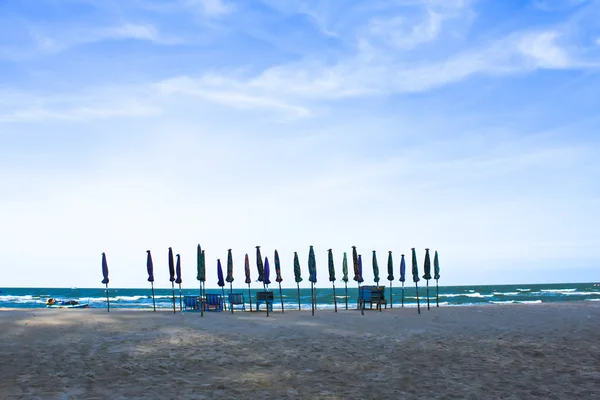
[[0, 282, 600, 310]]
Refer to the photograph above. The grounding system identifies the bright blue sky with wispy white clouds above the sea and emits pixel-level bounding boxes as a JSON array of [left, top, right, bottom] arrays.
[[0, 0, 600, 288]]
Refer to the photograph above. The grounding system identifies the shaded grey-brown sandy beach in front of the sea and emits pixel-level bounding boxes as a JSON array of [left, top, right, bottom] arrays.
[[0, 302, 600, 399]]
